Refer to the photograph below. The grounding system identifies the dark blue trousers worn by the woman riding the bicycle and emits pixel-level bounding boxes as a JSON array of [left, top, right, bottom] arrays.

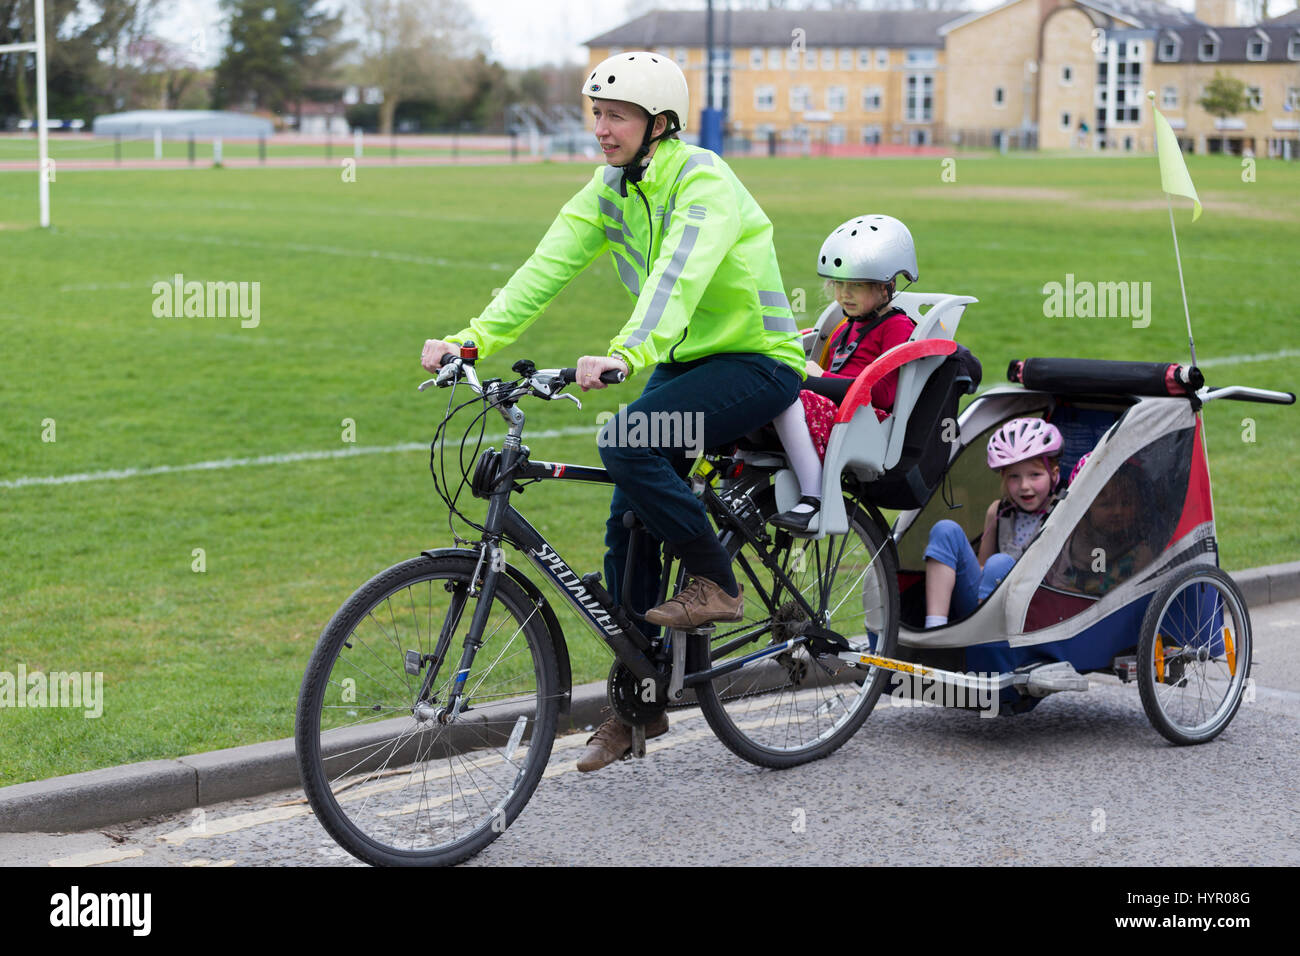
[[599, 352, 800, 614]]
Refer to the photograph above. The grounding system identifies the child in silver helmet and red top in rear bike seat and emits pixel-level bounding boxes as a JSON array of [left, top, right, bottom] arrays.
[[771, 215, 918, 531]]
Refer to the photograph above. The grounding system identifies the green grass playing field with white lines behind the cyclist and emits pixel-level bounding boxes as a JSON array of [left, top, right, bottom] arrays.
[[0, 156, 1300, 783]]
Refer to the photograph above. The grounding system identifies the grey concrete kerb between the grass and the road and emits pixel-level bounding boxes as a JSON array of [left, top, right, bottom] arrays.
[[10, 561, 1300, 832]]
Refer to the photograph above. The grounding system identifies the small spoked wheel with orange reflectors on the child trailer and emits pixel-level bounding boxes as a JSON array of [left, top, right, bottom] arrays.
[[1138, 566, 1253, 744]]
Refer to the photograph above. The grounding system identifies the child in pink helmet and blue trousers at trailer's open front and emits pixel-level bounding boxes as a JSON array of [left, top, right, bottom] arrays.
[[926, 419, 1065, 628]]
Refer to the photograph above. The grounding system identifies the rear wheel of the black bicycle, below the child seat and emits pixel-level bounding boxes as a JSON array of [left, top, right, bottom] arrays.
[[688, 489, 898, 769]]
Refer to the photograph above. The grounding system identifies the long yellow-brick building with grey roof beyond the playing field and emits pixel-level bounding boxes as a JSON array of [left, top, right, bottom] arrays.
[[586, 0, 1300, 159]]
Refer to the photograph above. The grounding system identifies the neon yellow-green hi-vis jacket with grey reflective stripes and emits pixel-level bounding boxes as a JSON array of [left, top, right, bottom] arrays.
[[447, 139, 805, 378]]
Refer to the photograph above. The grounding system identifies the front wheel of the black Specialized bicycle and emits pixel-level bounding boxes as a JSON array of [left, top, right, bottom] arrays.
[[295, 555, 559, 866]]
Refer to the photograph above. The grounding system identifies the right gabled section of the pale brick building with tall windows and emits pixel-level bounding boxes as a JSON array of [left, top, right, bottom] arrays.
[[940, 0, 1300, 156]]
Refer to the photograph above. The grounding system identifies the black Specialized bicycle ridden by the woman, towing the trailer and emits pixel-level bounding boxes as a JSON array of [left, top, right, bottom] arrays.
[[295, 343, 898, 865]]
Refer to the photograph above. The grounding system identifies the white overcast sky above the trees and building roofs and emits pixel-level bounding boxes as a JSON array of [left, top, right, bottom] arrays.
[[159, 0, 1295, 68]]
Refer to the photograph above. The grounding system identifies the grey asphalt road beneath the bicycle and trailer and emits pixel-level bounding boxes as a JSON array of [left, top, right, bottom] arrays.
[[0, 601, 1300, 866]]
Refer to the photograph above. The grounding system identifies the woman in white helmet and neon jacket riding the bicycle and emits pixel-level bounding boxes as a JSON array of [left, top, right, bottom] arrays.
[[421, 51, 805, 770]]
